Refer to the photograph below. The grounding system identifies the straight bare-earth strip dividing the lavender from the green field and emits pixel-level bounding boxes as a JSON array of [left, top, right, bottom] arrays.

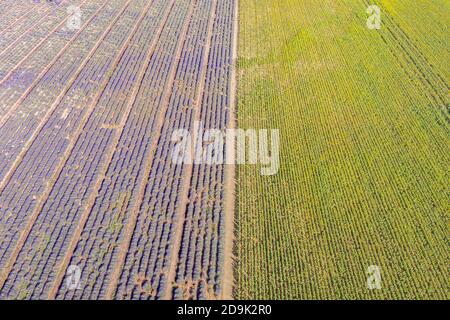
[[222, 0, 239, 300]]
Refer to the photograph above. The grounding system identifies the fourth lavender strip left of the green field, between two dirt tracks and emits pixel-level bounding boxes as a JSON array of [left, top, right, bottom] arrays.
[[0, 0, 178, 297]]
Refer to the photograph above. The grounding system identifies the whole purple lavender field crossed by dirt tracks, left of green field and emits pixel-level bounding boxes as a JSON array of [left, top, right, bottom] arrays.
[[0, 0, 236, 299]]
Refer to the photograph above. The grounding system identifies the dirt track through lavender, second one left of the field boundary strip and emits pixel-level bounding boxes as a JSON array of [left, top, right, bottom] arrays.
[[105, 0, 198, 300]]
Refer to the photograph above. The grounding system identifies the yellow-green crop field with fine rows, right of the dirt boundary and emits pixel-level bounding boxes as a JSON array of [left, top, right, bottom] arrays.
[[235, 0, 450, 299]]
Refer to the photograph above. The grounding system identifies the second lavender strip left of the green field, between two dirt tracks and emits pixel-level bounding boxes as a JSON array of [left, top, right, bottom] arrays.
[[112, 1, 216, 299]]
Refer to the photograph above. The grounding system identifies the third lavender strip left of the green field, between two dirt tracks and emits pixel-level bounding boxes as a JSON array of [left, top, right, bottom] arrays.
[[58, 1, 196, 299]]
